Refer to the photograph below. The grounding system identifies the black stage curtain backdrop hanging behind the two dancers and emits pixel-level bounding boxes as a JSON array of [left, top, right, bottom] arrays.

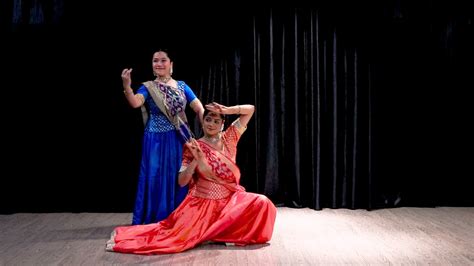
[[0, 0, 474, 213]]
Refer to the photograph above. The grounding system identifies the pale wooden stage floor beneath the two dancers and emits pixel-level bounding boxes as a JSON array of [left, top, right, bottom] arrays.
[[0, 207, 474, 265]]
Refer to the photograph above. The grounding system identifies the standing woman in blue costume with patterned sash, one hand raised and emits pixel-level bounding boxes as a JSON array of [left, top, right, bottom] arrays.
[[122, 50, 204, 225]]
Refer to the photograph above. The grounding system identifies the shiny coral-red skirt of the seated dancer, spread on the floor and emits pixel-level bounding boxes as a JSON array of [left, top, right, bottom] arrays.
[[106, 191, 276, 255]]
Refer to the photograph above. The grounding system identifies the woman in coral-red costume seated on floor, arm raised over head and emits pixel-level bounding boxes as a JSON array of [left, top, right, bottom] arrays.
[[106, 103, 276, 254]]
